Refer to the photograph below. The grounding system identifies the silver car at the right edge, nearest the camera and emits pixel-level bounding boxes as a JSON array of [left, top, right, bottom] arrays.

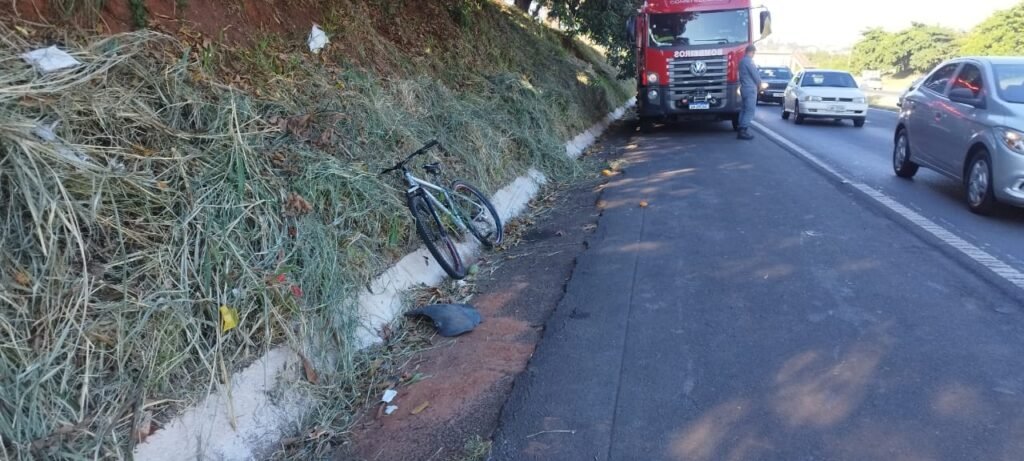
[[893, 57, 1024, 214]]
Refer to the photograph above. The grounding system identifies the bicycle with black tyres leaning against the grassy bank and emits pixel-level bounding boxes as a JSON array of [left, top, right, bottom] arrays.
[[380, 140, 504, 280]]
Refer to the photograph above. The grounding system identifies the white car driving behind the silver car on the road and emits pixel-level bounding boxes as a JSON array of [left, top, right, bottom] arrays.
[[782, 69, 867, 128]]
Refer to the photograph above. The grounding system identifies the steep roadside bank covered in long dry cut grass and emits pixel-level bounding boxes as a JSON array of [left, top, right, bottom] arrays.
[[0, 0, 629, 459]]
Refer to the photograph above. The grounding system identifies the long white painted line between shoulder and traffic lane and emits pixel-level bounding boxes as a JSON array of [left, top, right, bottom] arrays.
[[753, 121, 1024, 290]]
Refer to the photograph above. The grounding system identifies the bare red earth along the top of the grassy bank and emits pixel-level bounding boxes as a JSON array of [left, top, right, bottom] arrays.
[[0, 0, 459, 56]]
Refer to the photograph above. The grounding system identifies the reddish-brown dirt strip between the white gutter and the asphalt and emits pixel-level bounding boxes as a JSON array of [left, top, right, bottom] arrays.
[[336, 122, 633, 461]]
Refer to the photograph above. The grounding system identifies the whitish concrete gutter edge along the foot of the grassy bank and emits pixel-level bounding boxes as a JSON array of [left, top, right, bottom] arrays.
[[134, 98, 636, 461]]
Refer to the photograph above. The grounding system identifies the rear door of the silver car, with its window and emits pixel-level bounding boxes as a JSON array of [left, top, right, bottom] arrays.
[[904, 61, 961, 169]]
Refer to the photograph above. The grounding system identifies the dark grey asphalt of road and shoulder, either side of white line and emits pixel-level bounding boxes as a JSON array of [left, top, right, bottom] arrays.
[[492, 117, 1024, 461]]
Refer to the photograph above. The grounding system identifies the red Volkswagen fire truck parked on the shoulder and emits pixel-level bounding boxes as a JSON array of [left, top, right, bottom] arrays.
[[627, 0, 771, 131]]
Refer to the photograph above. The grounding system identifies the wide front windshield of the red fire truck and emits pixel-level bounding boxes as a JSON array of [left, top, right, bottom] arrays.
[[649, 9, 751, 47]]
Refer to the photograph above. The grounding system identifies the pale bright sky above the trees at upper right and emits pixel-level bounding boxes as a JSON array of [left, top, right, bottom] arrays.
[[764, 0, 1021, 48]]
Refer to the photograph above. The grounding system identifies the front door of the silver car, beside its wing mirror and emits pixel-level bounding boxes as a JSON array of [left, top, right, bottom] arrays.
[[935, 61, 986, 177]]
